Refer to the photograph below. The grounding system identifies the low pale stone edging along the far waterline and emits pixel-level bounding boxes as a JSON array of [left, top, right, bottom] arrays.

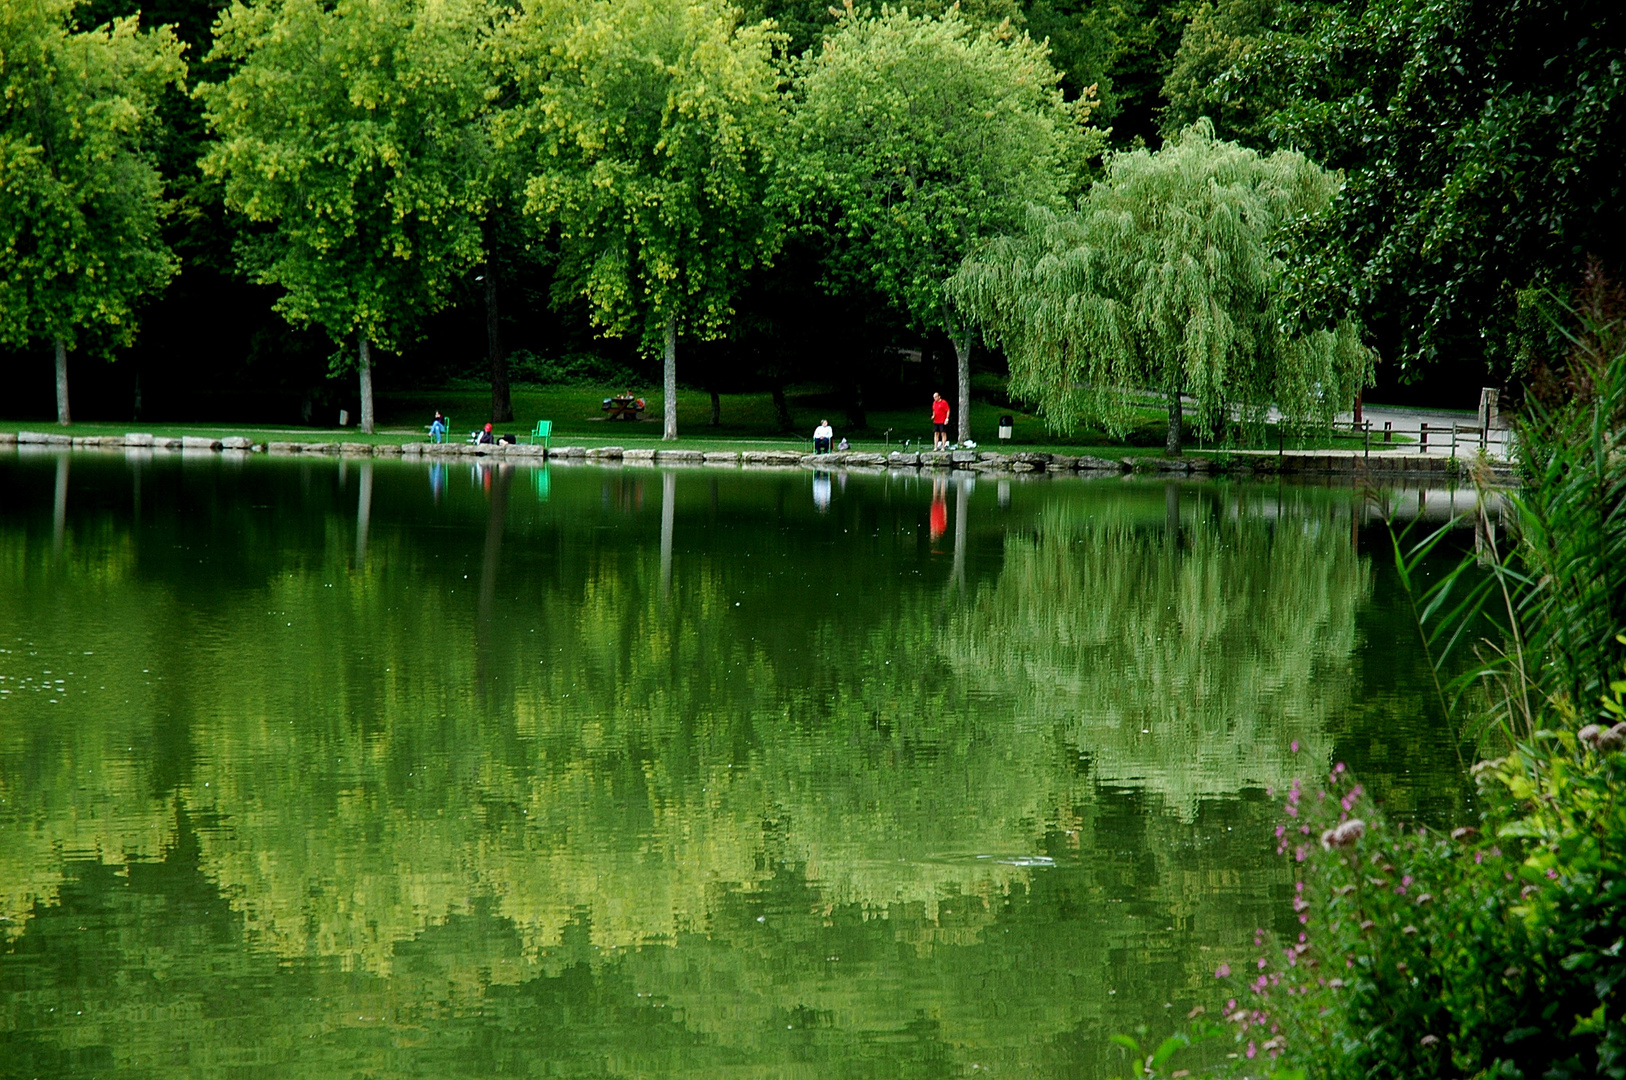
[[0, 431, 1512, 480]]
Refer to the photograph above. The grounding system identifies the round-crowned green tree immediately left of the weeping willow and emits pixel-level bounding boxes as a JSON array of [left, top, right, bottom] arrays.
[[782, 5, 1101, 441]]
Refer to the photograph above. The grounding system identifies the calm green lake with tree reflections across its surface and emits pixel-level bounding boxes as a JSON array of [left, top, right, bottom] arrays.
[[0, 451, 1472, 1080]]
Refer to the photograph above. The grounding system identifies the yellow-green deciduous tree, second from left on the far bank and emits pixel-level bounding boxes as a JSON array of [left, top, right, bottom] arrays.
[[198, 0, 488, 431]]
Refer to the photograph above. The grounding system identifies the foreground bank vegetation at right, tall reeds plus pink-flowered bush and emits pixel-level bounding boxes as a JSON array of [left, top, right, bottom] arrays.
[[1196, 286, 1626, 1080]]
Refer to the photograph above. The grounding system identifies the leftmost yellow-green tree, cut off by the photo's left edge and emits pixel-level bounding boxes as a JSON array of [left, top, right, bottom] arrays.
[[0, 0, 185, 423]]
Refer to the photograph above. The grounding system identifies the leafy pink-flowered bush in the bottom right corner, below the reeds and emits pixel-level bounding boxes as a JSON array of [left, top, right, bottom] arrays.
[[1221, 705, 1626, 1080]]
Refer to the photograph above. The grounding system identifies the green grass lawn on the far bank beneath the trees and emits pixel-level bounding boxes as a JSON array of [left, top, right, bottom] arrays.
[[0, 385, 1410, 457]]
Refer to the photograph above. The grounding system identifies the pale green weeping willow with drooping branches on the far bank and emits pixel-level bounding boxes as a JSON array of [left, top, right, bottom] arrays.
[[948, 120, 1372, 454]]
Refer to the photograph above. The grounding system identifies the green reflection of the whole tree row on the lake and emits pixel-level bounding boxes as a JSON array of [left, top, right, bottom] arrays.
[[0, 458, 1398, 1075]]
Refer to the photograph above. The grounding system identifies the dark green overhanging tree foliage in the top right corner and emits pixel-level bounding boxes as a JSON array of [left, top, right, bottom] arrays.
[[1164, 0, 1626, 385]]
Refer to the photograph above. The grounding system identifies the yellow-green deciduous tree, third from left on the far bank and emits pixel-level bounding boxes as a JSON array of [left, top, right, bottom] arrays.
[[498, 0, 780, 439]]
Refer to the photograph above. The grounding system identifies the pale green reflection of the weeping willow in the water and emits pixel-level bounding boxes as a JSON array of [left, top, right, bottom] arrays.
[[941, 488, 1371, 813]]
